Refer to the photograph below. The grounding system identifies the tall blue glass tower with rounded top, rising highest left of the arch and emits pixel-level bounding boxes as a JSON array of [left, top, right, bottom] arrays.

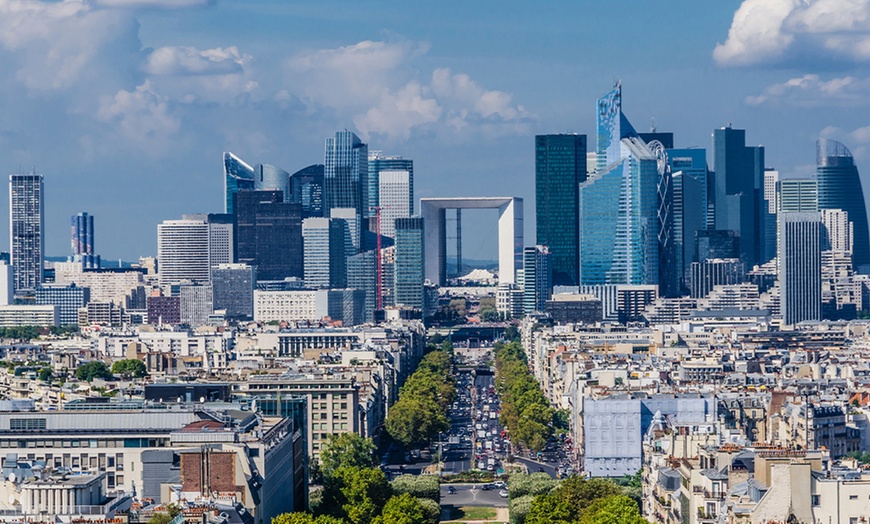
[[323, 131, 369, 245]]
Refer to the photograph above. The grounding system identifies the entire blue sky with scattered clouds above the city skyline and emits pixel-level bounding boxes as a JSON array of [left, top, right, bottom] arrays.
[[0, 0, 870, 260]]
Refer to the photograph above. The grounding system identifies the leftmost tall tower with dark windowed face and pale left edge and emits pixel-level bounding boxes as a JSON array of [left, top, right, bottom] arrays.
[[9, 173, 45, 294]]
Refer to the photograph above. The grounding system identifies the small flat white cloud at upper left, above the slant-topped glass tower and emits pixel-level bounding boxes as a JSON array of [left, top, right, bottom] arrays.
[[145, 46, 251, 75]]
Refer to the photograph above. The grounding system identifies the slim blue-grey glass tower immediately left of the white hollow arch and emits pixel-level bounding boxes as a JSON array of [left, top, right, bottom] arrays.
[[393, 217, 426, 310]]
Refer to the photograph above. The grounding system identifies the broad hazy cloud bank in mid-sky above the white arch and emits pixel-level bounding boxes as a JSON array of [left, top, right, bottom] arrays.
[[287, 41, 530, 140]]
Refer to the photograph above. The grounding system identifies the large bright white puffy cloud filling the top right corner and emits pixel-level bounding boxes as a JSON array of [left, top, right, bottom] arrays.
[[713, 0, 870, 66]]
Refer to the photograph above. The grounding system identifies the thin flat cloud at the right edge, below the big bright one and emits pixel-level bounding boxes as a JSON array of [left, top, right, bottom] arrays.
[[746, 74, 870, 107]]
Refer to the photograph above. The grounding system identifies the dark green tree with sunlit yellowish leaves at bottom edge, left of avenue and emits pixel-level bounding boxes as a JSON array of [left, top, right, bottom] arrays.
[[320, 467, 393, 524]]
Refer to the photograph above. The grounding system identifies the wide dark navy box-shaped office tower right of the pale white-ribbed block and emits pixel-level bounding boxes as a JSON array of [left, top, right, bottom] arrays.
[[235, 190, 304, 280]]
